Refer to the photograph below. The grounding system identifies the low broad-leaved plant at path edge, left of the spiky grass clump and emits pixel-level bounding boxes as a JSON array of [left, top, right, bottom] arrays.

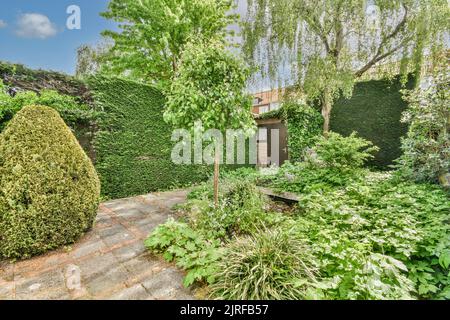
[[145, 219, 222, 287]]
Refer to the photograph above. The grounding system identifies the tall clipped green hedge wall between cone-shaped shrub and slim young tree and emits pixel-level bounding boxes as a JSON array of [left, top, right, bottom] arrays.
[[88, 77, 210, 198]]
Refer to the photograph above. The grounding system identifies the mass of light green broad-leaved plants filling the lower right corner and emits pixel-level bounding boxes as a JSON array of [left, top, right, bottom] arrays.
[[293, 174, 450, 299]]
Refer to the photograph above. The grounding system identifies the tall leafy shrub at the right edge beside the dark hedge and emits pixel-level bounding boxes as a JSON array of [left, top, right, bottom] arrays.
[[397, 66, 450, 182]]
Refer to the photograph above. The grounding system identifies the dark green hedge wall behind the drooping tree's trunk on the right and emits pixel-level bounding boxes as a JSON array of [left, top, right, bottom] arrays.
[[331, 78, 414, 169]]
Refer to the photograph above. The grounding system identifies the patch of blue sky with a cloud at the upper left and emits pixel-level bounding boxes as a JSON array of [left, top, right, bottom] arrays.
[[0, 0, 115, 74]]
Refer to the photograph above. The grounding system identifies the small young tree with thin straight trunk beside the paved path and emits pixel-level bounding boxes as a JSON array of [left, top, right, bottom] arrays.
[[164, 38, 255, 204]]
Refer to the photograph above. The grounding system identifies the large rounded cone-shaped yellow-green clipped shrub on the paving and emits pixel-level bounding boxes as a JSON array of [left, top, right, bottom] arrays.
[[0, 106, 100, 258]]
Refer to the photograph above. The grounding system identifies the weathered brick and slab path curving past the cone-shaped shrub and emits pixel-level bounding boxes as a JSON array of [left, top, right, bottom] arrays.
[[0, 191, 194, 300]]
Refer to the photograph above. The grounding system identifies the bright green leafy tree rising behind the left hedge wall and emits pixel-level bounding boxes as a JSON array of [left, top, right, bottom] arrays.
[[102, 0, 237, 87]]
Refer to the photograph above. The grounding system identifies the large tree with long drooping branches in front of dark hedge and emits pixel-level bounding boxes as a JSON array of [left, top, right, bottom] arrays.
[[244, 0, 450, 134]]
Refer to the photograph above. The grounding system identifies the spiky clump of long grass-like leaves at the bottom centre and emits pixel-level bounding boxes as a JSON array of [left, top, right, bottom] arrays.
[[211, 230, 316, 300]]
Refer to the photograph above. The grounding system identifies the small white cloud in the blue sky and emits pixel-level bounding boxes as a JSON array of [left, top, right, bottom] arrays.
[[16, 13, 58, 39]]
